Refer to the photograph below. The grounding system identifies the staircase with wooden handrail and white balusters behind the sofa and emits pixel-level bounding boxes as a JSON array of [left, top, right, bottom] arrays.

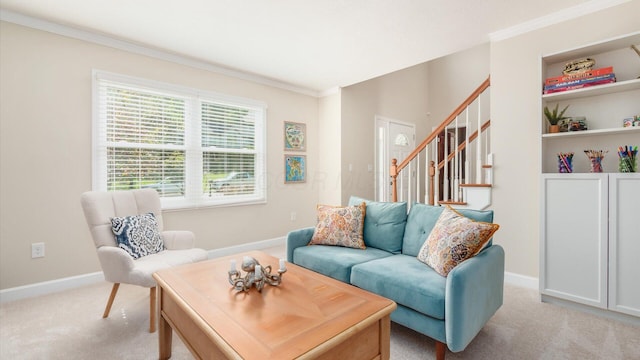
[[389, 78, 493, 210]]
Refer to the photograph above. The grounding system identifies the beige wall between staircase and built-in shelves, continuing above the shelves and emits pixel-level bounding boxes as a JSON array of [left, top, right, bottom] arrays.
[[491, 1, 640, 278]]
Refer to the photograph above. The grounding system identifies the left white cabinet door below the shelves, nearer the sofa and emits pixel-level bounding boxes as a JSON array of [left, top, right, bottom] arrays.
[[540, 174, 608, 309]]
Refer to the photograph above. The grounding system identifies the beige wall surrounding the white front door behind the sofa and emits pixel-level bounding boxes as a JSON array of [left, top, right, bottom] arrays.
[[341, 63, 428, 204]]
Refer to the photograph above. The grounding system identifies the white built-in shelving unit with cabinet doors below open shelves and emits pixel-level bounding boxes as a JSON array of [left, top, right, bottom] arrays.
[[540, 32, 640, 324]]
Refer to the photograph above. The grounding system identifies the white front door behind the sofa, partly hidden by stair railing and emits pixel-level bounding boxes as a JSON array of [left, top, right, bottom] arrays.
[[375, 115, 416, 204]]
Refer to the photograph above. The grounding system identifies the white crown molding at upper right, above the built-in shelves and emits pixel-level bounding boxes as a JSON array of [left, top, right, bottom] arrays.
[[489, 0, 632, 42]]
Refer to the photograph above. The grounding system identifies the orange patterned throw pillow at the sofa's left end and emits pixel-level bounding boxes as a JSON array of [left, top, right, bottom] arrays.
[[309, 202, 367, 249]]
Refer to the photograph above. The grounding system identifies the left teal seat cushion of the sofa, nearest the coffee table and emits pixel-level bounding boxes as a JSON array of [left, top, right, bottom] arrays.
[[293, 245, 392, 283]]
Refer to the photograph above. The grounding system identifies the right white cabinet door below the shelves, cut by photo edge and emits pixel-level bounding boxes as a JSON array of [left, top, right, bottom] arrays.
[[609, 174, 640, 316]]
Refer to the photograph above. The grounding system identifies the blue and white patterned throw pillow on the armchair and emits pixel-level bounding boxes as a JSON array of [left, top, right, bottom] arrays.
[[111, 213, 164, 259]]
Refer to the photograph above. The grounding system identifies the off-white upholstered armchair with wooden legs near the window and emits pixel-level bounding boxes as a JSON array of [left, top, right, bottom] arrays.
[[81, 189, 208, 332]]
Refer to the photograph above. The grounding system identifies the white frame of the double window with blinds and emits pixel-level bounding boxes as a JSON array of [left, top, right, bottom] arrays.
[[92, 69, 267, 209]]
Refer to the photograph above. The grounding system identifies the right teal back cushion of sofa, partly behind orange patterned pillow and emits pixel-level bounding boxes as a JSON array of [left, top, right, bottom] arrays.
[[402, 203, 493, 256]]
